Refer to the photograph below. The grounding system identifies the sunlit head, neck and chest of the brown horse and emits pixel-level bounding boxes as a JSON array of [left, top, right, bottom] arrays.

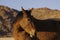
[[13, 8, 35, 40]]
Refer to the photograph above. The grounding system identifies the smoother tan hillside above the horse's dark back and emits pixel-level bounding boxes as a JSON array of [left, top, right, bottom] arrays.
[[32, 8, 60, 20]]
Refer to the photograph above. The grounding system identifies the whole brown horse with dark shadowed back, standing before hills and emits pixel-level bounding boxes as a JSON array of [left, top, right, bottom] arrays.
[[13, 8, 58, 40]]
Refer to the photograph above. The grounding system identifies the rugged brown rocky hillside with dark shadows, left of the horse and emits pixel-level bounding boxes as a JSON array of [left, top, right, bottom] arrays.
[[0, 5, 19, 36]]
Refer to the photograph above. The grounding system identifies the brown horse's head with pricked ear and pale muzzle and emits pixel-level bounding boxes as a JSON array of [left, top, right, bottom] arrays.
[[20, 7, 35, 37]]
